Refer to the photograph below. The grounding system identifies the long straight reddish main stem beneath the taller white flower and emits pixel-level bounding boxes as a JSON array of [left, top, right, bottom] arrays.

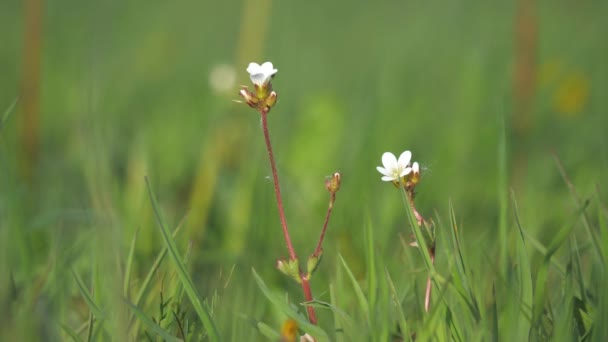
[[260, 110, 317, 325]]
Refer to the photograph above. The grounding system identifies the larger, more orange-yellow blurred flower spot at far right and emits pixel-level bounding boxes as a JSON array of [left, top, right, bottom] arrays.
[[553, 72, 589, 117]]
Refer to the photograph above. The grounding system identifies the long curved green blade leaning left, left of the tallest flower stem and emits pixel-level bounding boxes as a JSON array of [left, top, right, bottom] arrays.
[[145, 177, 221, 341]]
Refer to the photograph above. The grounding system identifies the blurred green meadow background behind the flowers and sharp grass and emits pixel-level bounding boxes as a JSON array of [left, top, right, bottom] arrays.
[[0, 0, 608, 336]]
